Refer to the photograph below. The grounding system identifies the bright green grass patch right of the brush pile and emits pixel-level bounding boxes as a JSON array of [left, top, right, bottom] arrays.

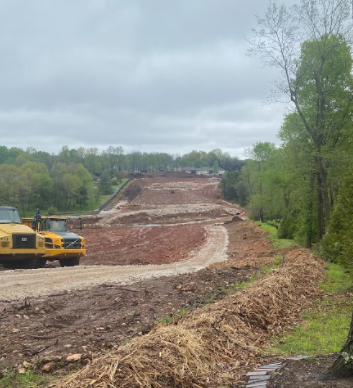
[[269, 264, 352, 355]]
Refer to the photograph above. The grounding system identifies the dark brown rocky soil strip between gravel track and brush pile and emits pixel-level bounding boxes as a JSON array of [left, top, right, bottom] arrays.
[[0, 222, 272, 371]]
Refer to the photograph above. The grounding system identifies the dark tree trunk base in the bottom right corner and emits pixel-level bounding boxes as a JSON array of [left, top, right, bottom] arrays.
[[326, 314, 353, 378]]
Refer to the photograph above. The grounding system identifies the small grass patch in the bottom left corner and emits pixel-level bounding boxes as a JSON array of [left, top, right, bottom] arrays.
[[0, 370, 51, 388]]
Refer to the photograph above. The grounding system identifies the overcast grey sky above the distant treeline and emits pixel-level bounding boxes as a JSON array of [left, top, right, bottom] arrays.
[[0, 0, 287, 157]]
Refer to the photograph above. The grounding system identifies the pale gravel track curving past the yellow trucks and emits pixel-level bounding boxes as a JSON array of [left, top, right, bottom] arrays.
[[0, 225, 228, 300]]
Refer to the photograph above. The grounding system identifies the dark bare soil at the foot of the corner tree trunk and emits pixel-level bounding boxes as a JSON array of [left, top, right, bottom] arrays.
[[269, 354, 353, 388]]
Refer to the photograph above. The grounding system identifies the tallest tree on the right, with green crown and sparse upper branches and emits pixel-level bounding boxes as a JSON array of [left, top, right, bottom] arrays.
[[251, 0, 353, 237]]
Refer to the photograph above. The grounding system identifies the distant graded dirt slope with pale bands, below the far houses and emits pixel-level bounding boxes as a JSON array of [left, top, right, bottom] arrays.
[[98, 177, 239, 227]]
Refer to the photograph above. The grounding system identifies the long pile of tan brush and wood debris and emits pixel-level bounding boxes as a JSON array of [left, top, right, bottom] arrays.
[[58, 249, 324, 388]]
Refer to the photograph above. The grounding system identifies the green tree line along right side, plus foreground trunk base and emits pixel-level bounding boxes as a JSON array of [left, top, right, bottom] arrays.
[[222, 0, 353, 376]]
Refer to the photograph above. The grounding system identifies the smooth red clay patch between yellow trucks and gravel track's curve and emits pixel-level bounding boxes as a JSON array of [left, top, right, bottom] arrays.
[[76, 225, 207, 265]]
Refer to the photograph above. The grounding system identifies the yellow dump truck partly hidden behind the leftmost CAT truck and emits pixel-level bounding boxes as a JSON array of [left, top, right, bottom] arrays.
[[22, 211, 86, 267]]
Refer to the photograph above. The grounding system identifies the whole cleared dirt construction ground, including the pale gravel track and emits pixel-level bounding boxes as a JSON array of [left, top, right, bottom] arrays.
[[0, 174, 344, 387]]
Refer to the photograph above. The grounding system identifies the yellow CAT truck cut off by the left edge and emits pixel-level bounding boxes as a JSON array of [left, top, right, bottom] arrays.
[[0, 206, 45, 269]]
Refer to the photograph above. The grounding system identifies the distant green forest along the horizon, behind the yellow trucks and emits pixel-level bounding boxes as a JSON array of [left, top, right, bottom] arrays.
[[0, 146, 244, 215]]
